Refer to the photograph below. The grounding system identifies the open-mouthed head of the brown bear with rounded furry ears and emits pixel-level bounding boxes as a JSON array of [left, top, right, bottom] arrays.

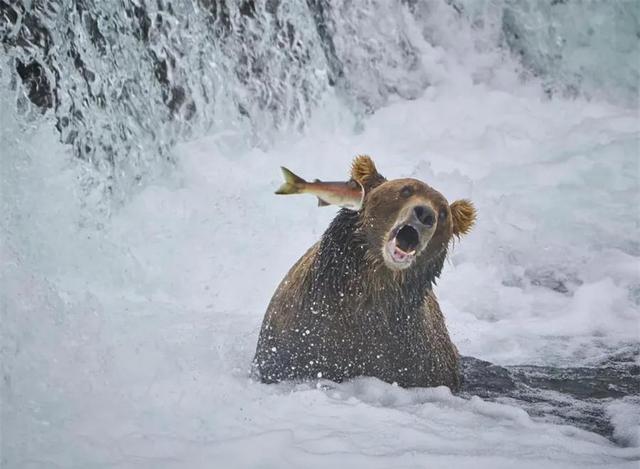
[[351, 156, 476, 271]]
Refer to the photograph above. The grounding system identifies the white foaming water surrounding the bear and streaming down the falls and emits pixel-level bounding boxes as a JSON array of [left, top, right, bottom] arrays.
[[0, 0, 640, 468]]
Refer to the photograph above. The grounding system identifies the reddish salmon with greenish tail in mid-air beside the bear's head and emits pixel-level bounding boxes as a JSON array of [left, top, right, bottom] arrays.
[[276, 166, 364, 210]]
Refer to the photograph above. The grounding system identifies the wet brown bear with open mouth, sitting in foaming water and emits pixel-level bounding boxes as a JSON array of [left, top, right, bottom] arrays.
[[254, 156, 475, 390]]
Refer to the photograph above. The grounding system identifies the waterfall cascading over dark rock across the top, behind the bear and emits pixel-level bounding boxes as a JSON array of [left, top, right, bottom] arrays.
[[0, 0, 640, 205]]
